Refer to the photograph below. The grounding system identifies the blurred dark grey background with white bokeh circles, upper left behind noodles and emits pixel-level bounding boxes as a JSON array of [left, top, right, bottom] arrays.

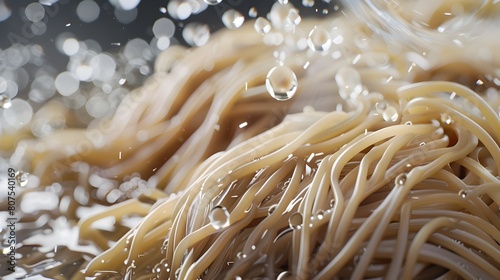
[[0, 0, 339, 133]]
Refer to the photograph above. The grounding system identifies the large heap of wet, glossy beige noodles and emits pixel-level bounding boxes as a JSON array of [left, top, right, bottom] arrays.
[[1, 2, 500, 279]]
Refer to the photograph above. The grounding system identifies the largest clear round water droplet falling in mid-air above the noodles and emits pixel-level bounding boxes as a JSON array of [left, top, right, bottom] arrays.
[[266, 66, 297, 101]]
